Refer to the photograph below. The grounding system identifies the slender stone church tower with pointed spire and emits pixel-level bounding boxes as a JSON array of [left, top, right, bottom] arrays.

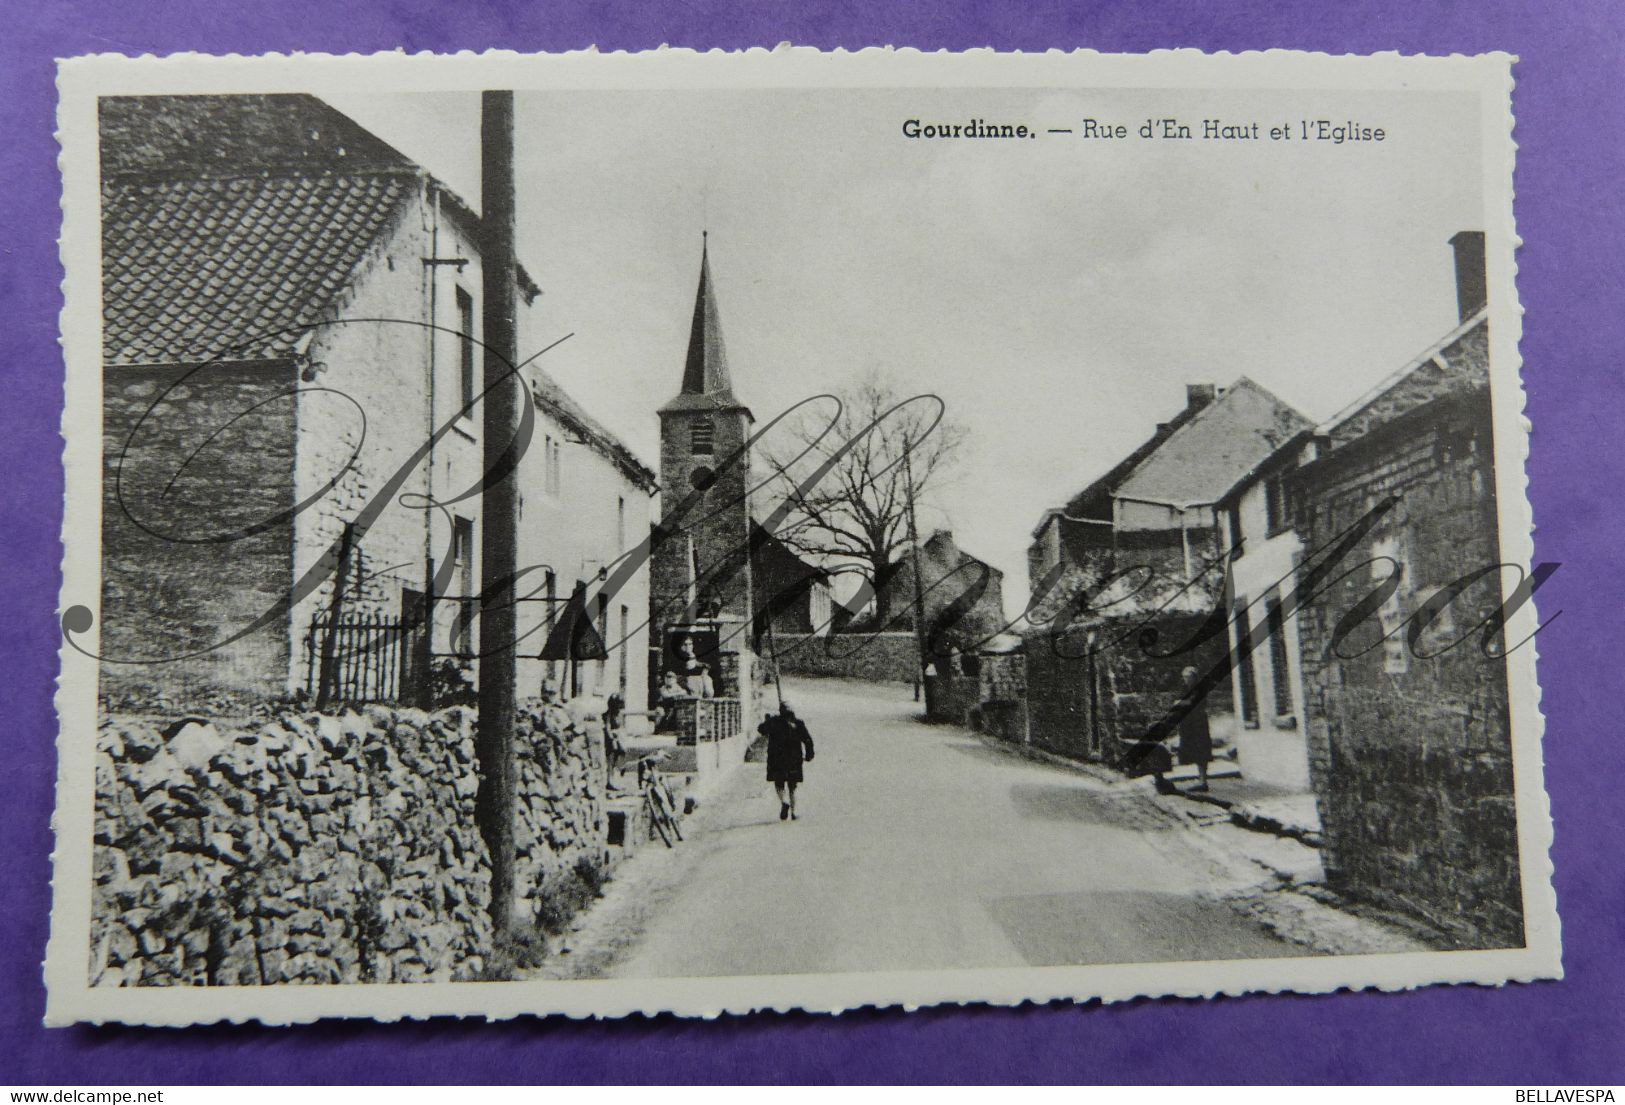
[[650, 244, 756, 694]]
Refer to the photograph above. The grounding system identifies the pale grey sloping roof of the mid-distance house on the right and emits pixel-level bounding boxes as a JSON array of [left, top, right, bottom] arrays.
[[1113, 377, 1310, 507]]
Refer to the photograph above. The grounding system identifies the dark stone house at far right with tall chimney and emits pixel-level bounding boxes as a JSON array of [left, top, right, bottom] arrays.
[[1290, 234, 1524, 947]]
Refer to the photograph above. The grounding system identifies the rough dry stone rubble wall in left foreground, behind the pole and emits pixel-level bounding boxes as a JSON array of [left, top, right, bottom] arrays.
[[89, 707, 606, 986]]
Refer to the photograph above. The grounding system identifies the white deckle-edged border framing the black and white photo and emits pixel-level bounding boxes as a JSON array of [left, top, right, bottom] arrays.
[[44, 47, 1562, 1025]]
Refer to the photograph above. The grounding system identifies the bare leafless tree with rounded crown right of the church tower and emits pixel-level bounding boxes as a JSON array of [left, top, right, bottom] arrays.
[[767, 371, 969, 626]]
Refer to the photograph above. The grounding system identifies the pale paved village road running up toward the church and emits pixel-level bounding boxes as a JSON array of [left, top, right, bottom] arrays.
[[609, 681, 1302, 978]]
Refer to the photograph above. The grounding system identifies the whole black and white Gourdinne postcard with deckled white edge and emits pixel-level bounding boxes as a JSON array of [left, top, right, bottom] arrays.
[[46, 47, 1562, 1024]]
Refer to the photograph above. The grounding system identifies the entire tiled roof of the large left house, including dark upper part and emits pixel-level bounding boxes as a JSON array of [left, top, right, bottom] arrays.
[[99, 94, 540, 364]]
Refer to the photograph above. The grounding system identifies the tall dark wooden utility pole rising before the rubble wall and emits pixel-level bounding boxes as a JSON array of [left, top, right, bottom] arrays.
[[476, 91, 523, 934]]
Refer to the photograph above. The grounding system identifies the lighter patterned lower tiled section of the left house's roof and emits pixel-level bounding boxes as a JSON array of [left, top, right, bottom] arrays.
[[102, 172, 418, 364]]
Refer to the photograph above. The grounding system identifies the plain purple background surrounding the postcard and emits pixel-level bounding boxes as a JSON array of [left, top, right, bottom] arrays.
[[0, 0, 1625, 1086]]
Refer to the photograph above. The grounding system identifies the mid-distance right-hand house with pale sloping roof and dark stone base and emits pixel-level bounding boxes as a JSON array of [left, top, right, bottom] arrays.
[[1024, 377, 1308, 765]]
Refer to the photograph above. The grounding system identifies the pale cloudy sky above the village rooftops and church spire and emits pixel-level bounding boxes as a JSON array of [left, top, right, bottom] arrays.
[[327, 88, 1485, 614]]
